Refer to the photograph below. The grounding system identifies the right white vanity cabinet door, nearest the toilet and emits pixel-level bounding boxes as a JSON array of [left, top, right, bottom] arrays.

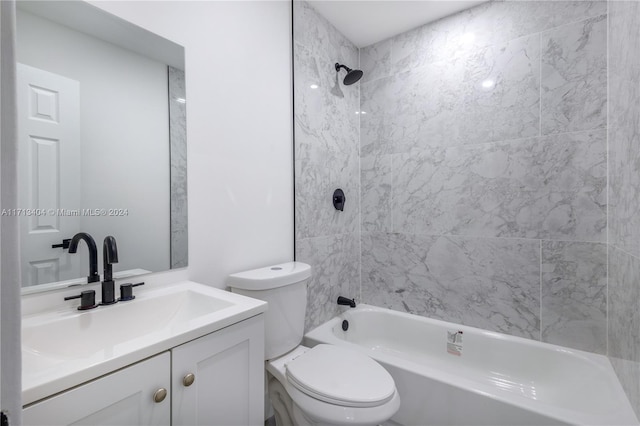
[[171, 315, 264, 426]]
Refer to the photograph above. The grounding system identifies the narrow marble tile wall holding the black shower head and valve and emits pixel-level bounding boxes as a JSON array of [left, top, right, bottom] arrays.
[[293, 1, 360, 330]]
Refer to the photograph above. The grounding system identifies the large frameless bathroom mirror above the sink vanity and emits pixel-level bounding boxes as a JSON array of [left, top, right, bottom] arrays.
[[16, 1, 187, 293]]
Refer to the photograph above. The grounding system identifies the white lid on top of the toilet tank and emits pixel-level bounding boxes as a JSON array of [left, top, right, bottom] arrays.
[[227, 262, 311, 290]]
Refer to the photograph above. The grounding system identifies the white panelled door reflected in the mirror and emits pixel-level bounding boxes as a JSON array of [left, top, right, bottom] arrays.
[[18, 64, 84, 286]]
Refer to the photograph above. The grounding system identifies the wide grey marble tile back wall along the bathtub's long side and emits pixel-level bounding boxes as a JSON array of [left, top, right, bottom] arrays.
[[360, 1, 607, 353]]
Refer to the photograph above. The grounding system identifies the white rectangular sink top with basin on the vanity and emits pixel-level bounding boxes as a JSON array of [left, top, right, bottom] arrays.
[[22, 282, 266, 404]]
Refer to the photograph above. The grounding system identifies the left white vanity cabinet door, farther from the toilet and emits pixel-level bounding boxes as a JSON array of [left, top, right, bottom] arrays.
[[23, 352, 171, 426]]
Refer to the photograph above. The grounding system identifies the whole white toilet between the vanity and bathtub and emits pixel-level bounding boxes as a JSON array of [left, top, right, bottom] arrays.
[[227, 262, 400, 426]]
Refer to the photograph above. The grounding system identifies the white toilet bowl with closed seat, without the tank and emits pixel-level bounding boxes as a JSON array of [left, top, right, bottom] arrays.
[[267, 345, 400, 425]]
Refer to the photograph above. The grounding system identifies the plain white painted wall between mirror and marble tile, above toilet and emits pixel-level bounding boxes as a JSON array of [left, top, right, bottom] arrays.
[[92, 1, 293, 287]]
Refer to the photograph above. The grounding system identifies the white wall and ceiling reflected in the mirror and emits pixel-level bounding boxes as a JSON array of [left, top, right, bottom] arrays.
[[17, 11, 170, 272]]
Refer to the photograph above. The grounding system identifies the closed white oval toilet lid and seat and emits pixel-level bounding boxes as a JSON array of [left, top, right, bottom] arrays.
[[285, 344, 396, 408]]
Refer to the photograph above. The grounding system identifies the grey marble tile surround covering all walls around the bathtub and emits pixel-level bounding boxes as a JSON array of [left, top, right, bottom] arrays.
[[294, 1, 640, 407]]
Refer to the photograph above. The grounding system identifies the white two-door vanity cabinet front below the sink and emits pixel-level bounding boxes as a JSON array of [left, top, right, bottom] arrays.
[[23, 315, 264, 426]]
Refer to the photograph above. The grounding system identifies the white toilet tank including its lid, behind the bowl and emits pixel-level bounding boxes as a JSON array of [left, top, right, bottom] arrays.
[[227, 262, 311, 359]]
